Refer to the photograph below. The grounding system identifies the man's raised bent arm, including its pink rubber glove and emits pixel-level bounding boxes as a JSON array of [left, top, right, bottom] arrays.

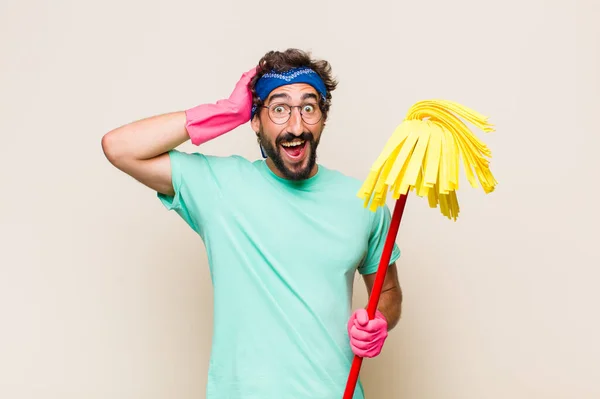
[[102, 67, 256, 195]]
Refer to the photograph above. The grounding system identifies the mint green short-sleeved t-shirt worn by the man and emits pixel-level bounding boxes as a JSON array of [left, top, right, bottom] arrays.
[[158, 150, 400, 399]]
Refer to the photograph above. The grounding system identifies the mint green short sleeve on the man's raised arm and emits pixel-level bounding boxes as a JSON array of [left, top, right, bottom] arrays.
[[157, 150, 236, 235]]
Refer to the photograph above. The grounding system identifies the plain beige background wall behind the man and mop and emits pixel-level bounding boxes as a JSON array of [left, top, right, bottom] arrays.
[[0, 0, 600, 399]]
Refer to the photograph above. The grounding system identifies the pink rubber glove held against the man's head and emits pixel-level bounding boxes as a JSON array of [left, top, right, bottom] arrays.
[[185, 67, 256, 145]]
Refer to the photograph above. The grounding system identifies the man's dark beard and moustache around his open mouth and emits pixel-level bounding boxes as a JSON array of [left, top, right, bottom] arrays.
[[258, 130, 319, 180]]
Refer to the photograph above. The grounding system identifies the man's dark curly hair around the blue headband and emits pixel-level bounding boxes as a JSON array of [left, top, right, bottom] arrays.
[[250, 48, 338, 119]]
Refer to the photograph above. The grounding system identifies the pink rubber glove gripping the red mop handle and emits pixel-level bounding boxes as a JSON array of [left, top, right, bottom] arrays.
[[348, 309, 388, 357]]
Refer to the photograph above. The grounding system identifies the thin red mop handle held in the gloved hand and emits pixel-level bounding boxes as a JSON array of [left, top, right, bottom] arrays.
[[343, 195, 407, 399]]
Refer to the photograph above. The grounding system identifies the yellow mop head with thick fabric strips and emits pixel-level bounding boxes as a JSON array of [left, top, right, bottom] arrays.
[[358, 100, 497, 220]]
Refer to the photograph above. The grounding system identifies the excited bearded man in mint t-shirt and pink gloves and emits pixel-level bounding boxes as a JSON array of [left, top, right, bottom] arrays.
[[102, 49, 402, 399]]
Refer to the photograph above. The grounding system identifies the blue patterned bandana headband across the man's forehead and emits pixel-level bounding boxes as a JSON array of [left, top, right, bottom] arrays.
[[250, 67, 327, 118]]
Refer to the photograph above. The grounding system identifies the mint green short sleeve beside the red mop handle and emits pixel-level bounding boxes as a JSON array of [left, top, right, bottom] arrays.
[[358, 205, 400, 274]]
